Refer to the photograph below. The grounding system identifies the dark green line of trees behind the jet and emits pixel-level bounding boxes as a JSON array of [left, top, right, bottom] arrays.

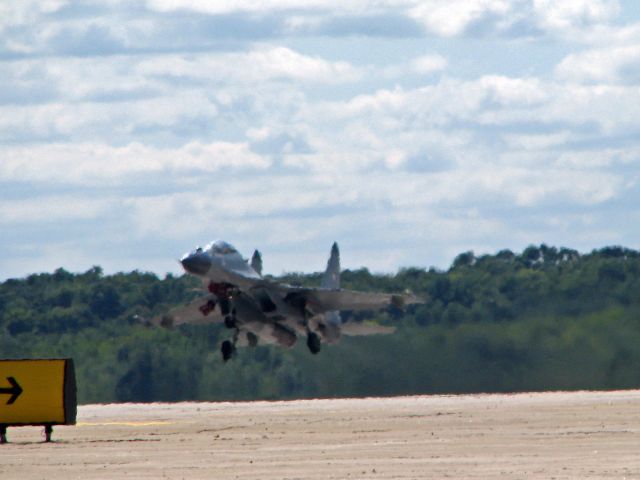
[[0, 245, 640, 403]]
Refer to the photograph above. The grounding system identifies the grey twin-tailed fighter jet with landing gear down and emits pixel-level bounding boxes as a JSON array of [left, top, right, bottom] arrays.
[[151, 240, 422, 362]]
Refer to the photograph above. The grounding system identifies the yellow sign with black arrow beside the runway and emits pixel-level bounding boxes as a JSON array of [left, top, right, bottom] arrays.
[[0, 359, 77, 425]]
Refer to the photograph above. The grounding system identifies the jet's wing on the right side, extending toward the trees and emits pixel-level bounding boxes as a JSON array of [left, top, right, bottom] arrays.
[[285, 288, 423, 314]]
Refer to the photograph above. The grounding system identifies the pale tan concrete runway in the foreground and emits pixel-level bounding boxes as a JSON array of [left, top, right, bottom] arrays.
[[0, 390, 640, 480]]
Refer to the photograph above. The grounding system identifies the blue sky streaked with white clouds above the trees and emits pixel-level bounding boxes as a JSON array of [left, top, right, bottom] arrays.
[[0, 0, 640, 280]]
